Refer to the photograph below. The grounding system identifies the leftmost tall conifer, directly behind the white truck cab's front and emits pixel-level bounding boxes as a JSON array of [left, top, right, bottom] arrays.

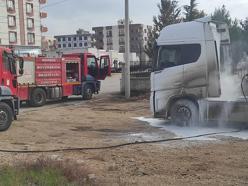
[[145, 0, 182, 58]]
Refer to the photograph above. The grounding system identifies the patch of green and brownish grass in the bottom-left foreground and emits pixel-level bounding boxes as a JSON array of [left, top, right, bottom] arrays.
[[0, 158, 94, 186]]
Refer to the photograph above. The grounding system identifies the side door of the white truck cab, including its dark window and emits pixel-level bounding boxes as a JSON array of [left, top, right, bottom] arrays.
[[151, 45, 183, 112]]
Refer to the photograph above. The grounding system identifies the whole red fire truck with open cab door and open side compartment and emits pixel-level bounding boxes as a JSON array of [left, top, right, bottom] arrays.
[[18, 53, 110, 107]]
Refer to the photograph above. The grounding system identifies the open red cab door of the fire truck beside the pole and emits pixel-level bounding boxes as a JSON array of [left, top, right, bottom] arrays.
[[98, 55, 111, 80]]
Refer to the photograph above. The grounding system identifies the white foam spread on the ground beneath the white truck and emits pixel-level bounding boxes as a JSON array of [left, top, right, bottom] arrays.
[[134, 117, 248, 140]]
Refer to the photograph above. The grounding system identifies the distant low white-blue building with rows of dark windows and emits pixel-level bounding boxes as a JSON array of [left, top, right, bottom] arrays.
[[55, 29, 93, 52]]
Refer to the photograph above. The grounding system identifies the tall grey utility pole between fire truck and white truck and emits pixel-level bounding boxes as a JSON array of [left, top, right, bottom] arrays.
[[125, 0, 130, 99]]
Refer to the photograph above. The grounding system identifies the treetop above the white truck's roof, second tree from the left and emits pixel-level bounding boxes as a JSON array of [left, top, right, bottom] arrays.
[[183, 0, 206, 21]]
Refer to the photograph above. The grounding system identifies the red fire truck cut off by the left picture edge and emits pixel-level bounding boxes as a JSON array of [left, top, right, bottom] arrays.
[[0, 47, 23, 131]]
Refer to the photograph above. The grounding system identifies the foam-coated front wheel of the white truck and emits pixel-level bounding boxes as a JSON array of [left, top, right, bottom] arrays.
[[170, 99, 199, 126]]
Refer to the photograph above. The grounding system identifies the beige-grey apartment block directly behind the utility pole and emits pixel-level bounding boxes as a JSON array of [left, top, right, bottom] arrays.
[[92, 20, 152, 61]]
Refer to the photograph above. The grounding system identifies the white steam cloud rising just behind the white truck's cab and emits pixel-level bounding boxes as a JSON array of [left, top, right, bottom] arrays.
[[205, 47, 248, 127]]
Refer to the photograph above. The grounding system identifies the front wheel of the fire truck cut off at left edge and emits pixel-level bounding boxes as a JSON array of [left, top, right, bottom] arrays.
[[0, 102, 13, 131]]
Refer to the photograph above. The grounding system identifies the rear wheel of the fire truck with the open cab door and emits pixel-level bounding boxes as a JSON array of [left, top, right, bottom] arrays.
[[30, 88, 46, 107]]
